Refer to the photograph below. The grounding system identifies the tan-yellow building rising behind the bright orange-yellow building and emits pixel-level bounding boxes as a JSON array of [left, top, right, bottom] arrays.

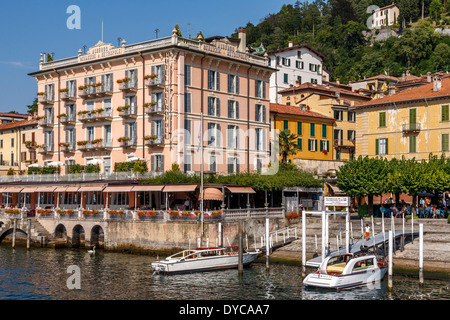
[[279, 83, 371, 160]]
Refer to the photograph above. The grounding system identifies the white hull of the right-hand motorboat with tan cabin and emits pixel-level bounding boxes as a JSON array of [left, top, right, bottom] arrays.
[[303, 268, 387, 290]]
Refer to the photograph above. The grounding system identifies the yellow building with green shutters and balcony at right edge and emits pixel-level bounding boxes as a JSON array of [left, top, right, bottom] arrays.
[[351, 75, 450, 160]]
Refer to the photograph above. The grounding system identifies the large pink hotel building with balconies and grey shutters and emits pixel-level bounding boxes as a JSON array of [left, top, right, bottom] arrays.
[[30, 29, 276, 174]]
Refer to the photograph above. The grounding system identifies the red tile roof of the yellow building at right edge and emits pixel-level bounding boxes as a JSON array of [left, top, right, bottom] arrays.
[[352, 78, 450, 108]]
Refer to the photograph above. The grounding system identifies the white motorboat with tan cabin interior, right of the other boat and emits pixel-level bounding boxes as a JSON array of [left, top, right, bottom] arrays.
[[303, 253, 388, 289]]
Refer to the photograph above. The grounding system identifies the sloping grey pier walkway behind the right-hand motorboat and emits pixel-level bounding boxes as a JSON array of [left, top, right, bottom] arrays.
[[306, 230, 419, 267]]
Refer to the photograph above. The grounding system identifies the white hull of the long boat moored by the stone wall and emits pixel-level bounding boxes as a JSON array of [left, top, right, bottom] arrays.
[[152, 252, 259, 274]]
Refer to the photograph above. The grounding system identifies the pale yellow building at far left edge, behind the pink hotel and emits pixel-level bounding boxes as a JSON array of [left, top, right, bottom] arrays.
[[0, 119, 38, 175]]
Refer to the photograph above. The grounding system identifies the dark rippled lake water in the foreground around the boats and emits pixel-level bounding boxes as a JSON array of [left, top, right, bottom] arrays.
[[0, 245, 450, 300]]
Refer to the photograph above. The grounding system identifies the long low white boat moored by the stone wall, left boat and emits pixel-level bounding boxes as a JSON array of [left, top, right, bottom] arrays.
[[152, 247, 260, 274]]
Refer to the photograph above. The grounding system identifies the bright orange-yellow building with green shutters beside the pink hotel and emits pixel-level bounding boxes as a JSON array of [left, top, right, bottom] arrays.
[[270, 103, 334, 162]]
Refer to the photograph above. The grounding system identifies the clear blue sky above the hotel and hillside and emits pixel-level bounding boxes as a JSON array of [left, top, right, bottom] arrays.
[[0, 0, 295, 113]]
